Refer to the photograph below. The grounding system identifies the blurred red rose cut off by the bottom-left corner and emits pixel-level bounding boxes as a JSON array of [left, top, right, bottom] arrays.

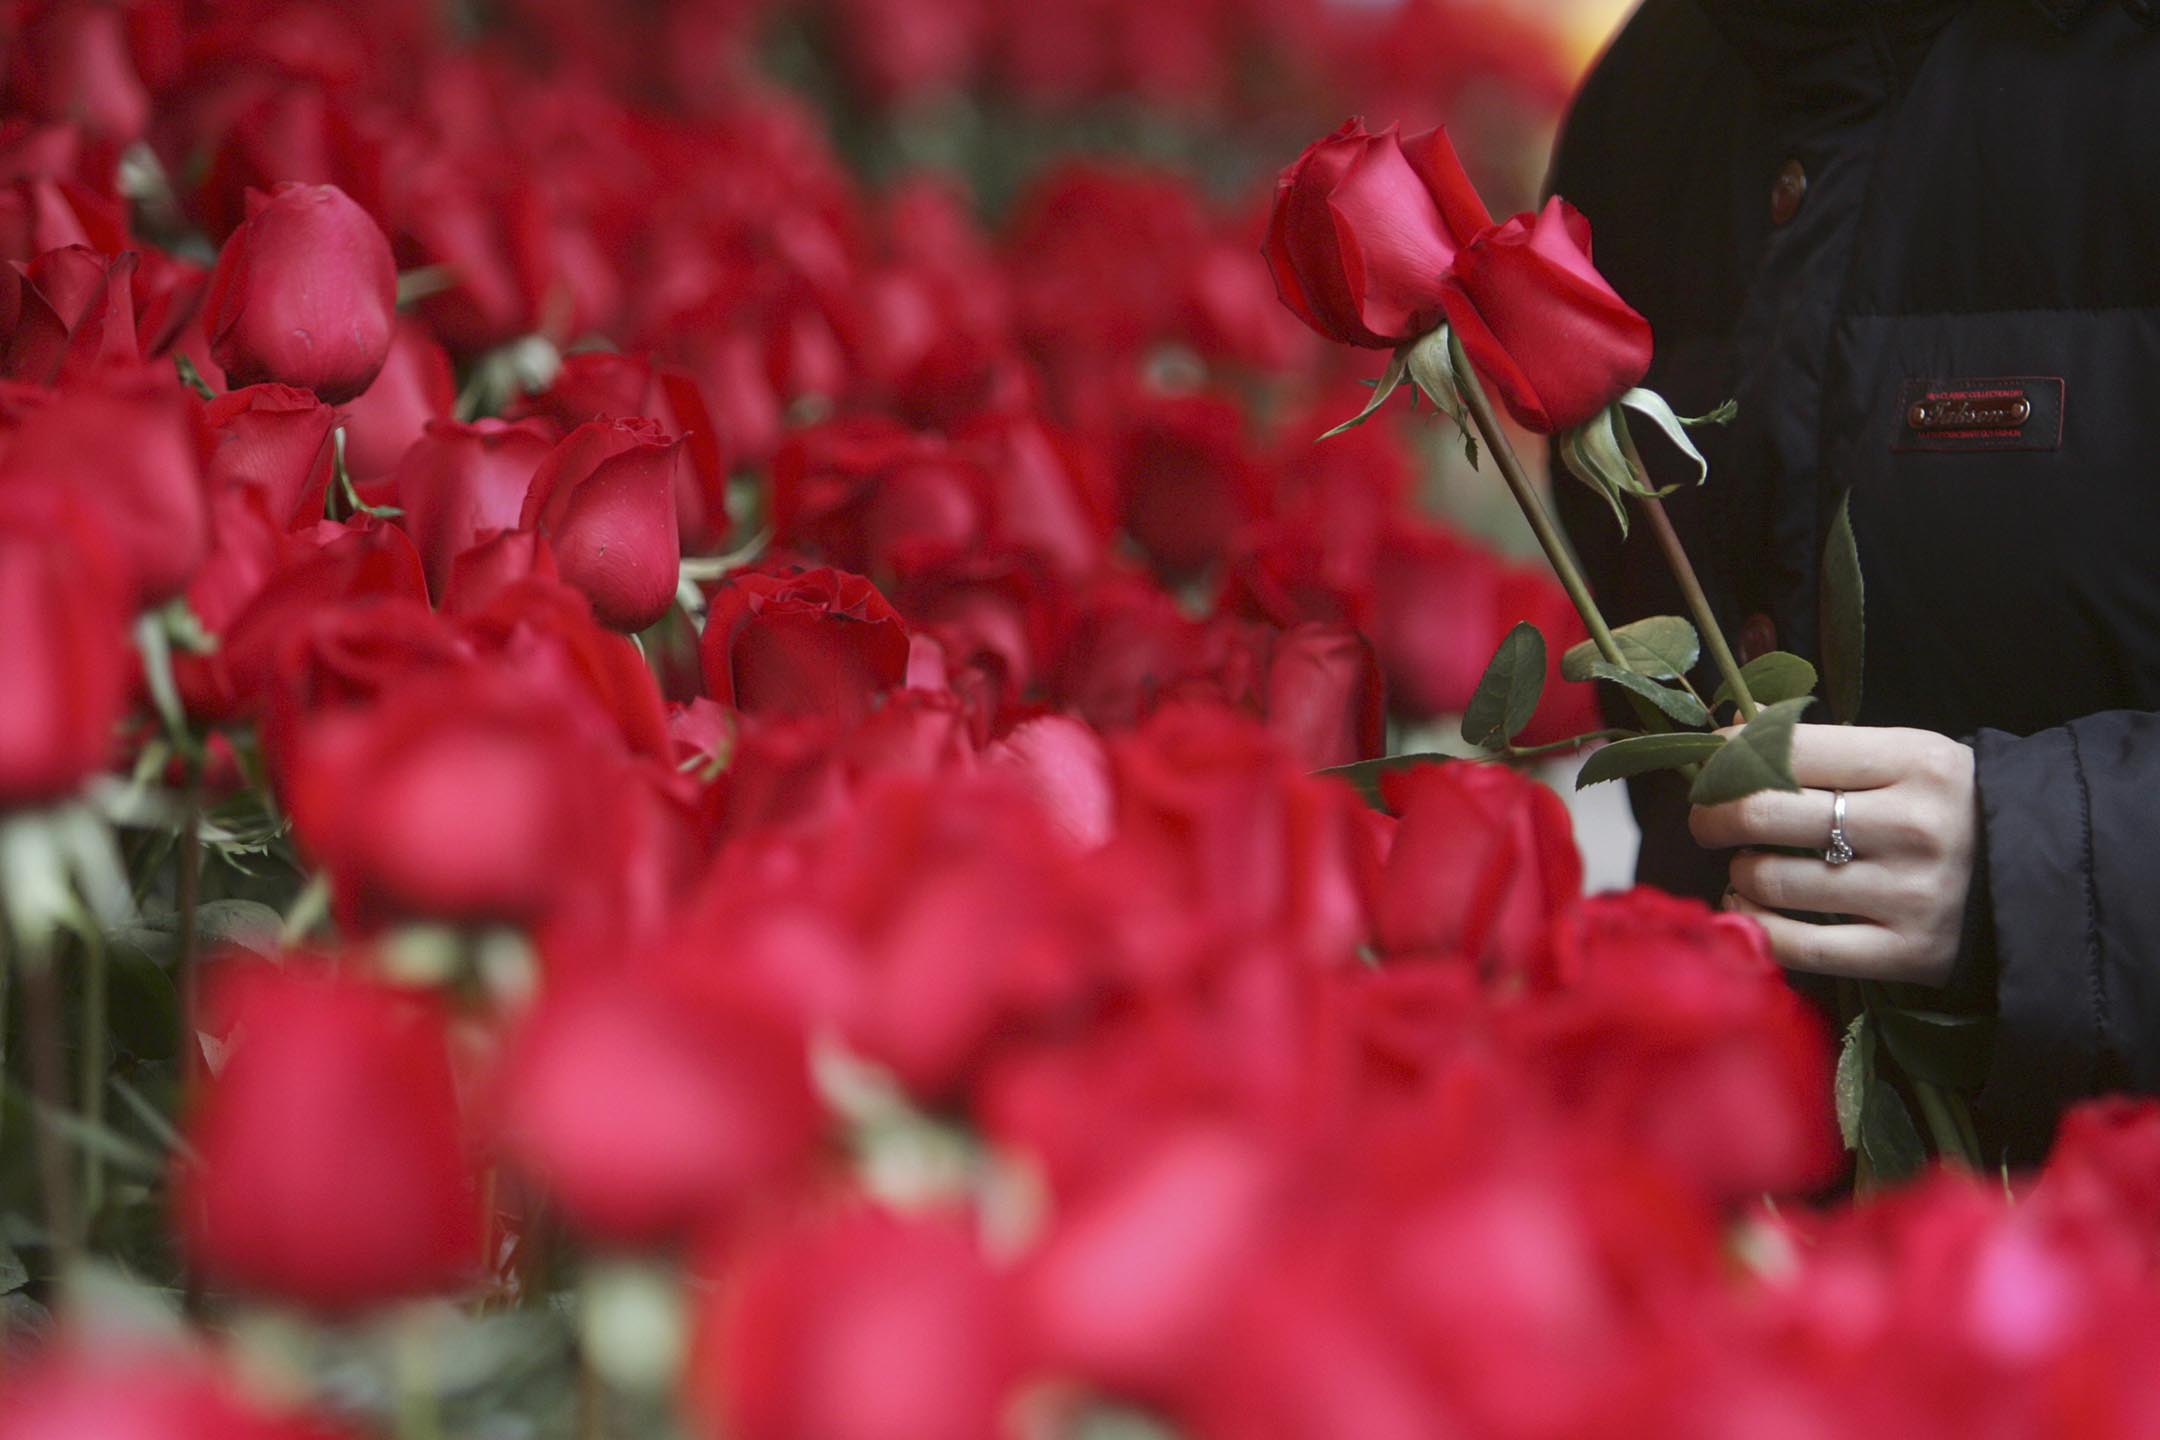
[[0, 1339, 339, 1440]]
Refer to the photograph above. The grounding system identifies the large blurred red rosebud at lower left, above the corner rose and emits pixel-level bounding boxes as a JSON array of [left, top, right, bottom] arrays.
[[175, 961, 480, 1313]]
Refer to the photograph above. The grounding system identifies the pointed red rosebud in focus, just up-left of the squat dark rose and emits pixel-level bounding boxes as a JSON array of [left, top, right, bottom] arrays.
[[518, 419, 683, 635]]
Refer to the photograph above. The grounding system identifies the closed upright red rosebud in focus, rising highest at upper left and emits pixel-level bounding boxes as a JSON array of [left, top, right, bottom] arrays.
[[205, 184, 397, 406]]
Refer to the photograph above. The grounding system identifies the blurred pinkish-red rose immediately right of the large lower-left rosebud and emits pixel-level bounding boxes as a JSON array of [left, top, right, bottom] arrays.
[[501, 974, 823, 1244]]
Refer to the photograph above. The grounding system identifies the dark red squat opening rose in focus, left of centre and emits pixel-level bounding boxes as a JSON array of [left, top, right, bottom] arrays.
[[700, 570, 907, 719]]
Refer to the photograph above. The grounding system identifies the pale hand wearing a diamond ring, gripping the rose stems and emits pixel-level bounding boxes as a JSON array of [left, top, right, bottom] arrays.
[[1687, 725, 1979, 984]]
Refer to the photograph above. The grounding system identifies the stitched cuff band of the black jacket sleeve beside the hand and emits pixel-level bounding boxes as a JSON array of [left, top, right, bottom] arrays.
[[1972, 728, 2102, 1164]]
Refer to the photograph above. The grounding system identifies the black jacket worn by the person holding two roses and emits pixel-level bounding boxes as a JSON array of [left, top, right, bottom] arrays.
[[1553, 0, 2160, 1159]]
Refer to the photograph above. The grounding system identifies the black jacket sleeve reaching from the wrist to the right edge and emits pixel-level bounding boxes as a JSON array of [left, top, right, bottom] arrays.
[[1974, 710, 2160, 1164]]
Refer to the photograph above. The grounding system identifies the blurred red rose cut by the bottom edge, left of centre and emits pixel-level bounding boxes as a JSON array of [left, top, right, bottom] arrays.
[[693, 1213, 1015, 1440]]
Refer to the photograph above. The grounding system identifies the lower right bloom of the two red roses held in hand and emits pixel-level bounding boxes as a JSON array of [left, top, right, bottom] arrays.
[[1443, 194, 1650, 434]]
